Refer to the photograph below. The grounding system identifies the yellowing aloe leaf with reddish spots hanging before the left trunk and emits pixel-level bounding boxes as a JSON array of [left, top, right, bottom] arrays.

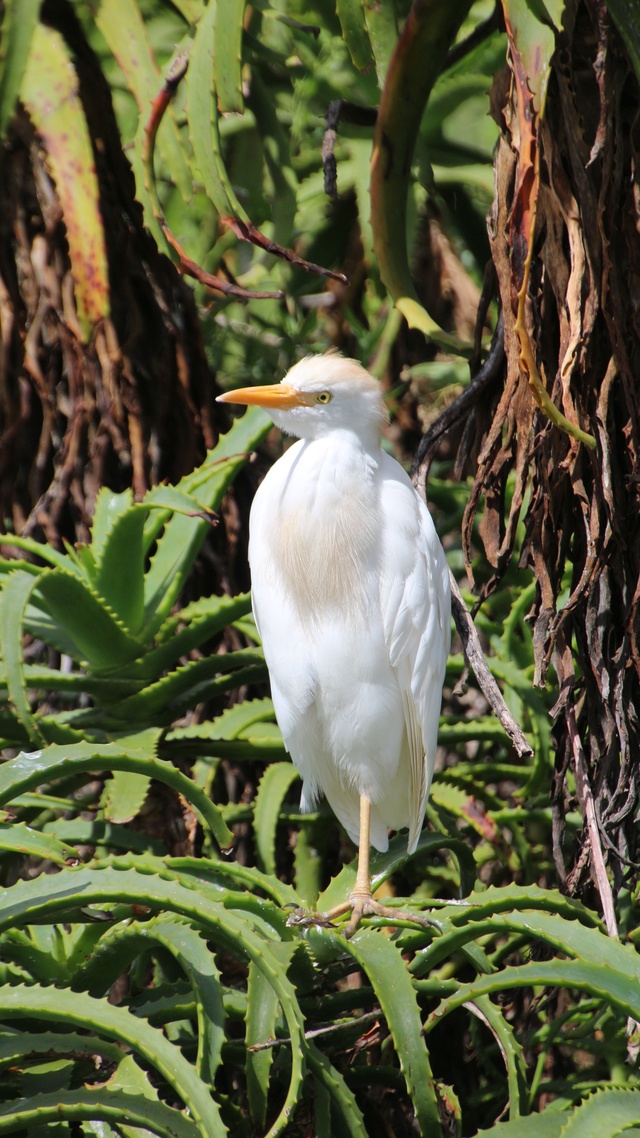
[[20, 24, 109, 340]]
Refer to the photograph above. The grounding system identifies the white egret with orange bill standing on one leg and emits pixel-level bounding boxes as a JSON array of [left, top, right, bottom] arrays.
[[218, 353, 451, 935]]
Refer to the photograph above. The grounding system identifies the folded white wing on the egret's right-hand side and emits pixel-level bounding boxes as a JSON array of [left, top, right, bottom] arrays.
[[380, 456, 451, 851]]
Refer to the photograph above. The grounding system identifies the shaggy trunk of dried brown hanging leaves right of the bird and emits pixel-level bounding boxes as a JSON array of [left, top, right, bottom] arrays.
[[463, 2, 640, 896]]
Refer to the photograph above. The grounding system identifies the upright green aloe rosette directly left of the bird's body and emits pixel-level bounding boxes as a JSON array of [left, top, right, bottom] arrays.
[[0, 405, 268, 747]]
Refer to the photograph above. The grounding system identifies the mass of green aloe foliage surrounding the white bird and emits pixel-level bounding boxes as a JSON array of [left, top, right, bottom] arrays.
[[0, 0, 640, 1138]]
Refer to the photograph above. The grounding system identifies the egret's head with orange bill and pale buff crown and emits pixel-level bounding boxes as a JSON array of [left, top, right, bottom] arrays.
[[218, 353, 388, 439]]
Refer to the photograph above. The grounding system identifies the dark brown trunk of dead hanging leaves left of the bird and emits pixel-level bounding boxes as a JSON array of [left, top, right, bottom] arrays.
[[0, 0, 215, 545]]
